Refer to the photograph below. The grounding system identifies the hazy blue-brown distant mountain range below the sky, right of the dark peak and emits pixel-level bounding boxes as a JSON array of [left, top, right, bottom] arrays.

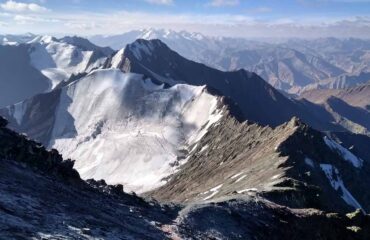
[[89, 29, 370, 94]]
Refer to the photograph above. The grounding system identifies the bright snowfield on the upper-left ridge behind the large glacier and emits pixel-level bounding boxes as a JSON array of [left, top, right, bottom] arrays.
[[30, 36, 106, 89]]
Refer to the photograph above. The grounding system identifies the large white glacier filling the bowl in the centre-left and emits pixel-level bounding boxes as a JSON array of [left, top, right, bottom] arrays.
[[49, 69, 221, 192]]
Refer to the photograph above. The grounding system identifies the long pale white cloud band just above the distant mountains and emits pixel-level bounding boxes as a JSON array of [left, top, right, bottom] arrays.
[[0, 6, 370, 38]]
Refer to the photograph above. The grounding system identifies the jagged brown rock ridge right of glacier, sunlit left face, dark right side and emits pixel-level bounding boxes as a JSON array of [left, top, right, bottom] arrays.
[[149, 116, 370, 212]]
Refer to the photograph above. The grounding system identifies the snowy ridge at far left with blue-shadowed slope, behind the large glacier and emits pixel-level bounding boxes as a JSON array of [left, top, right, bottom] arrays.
[[0, 34, 114, 107]]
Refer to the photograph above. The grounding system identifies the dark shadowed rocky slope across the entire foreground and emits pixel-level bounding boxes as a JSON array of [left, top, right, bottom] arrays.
[[0, 117, 370, 239]]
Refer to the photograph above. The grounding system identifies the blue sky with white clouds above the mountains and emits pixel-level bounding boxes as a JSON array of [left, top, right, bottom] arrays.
[[0, 0, 370, 38]]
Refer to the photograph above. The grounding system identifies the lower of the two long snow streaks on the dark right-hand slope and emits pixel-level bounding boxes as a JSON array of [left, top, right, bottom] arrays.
[[320, 164, 365, 213]]
